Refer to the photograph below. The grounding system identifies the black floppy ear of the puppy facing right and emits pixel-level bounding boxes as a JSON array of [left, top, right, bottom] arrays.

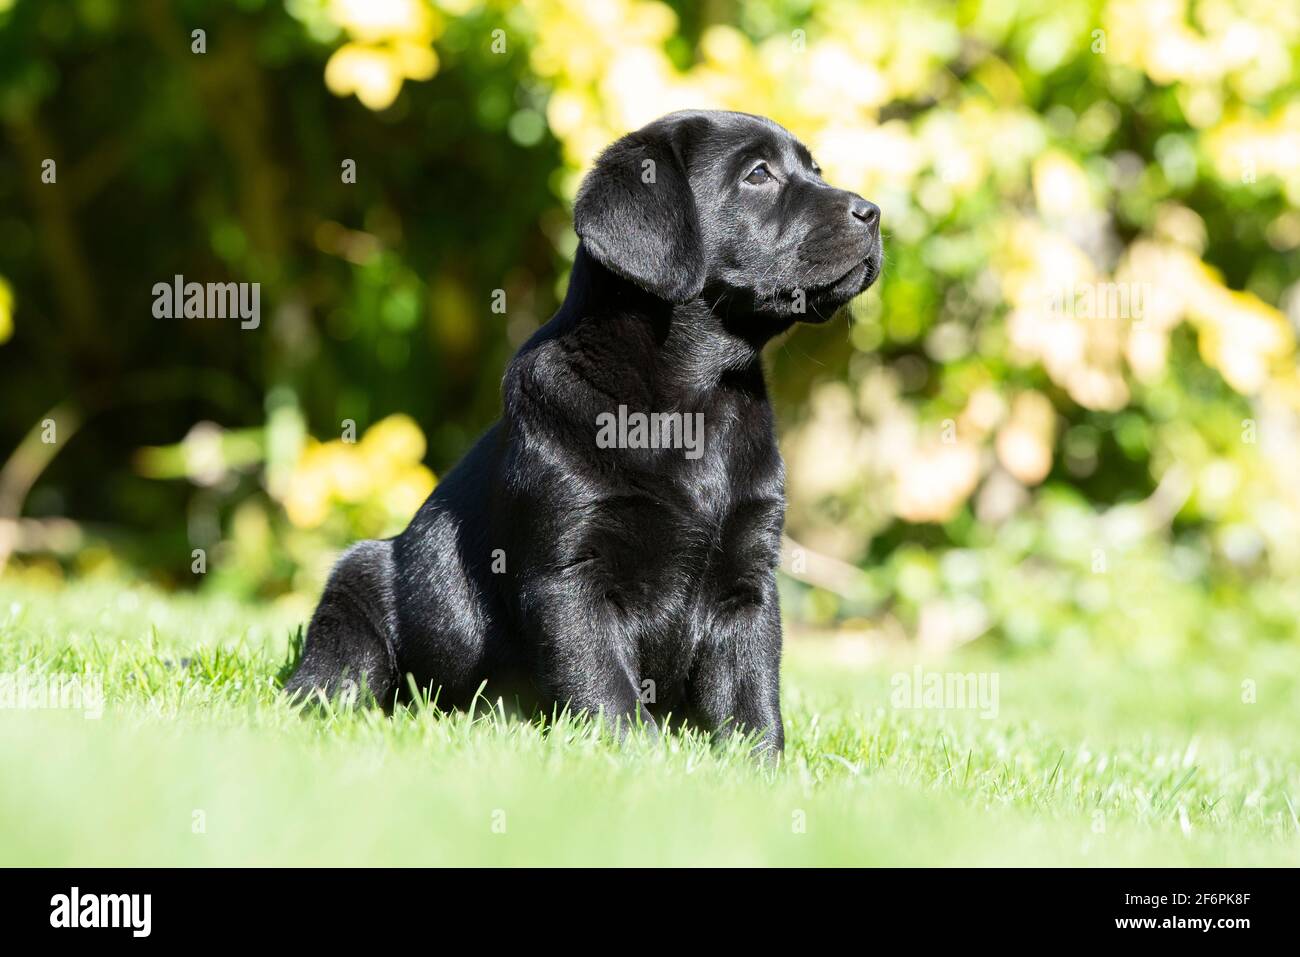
[[573, 120, 705, 303]]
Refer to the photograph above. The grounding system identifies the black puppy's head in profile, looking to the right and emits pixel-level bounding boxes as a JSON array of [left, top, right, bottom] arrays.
[[573, 111, 881, 322]]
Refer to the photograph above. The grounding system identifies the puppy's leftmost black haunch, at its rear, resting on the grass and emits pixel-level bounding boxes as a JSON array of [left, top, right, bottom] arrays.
[[285, 541, 399, 710]]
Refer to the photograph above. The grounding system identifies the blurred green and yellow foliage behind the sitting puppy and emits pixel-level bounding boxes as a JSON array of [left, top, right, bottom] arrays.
[[0, 0, 1300, 653]]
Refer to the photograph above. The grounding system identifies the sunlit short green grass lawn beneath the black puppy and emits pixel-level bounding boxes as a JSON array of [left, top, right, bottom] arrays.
[[0, 580, 1300, 865]]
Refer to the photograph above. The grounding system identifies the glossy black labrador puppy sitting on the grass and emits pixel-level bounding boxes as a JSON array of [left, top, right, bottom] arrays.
[[287, 112, 881, 753]]
